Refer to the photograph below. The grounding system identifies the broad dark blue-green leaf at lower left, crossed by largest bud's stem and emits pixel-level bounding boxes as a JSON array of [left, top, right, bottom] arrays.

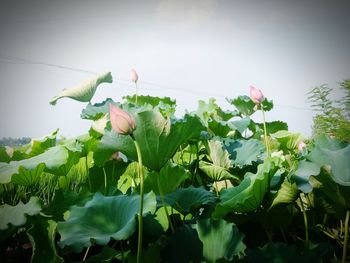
[[57, 192, 156, 252]]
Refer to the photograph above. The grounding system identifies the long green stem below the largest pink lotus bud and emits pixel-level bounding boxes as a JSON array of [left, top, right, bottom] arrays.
[[134, 140, 144, 263]]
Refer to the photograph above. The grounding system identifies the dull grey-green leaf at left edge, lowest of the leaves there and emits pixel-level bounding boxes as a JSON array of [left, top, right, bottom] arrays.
[[0, 196, 41, 230]]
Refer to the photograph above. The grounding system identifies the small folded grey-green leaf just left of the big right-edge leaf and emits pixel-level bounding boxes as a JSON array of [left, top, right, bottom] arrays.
[[293, 160, 321, 193]]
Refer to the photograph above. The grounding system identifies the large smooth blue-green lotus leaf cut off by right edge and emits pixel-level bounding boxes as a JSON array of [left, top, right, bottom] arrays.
[[307, 137, 350, 186]]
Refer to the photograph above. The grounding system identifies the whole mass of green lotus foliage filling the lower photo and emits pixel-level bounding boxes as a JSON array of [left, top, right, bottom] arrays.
[[0, 74, 350, 262]]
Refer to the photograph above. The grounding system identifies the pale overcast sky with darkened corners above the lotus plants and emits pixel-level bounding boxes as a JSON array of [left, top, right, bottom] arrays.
[[0, 0, 350, 137]]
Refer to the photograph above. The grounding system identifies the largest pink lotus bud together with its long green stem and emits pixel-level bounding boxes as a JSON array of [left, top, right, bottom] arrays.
[[109, 104, 144, 263]]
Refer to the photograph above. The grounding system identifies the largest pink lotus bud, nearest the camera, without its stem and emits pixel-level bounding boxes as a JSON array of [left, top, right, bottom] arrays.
[[109, 104, 136, 135]]
